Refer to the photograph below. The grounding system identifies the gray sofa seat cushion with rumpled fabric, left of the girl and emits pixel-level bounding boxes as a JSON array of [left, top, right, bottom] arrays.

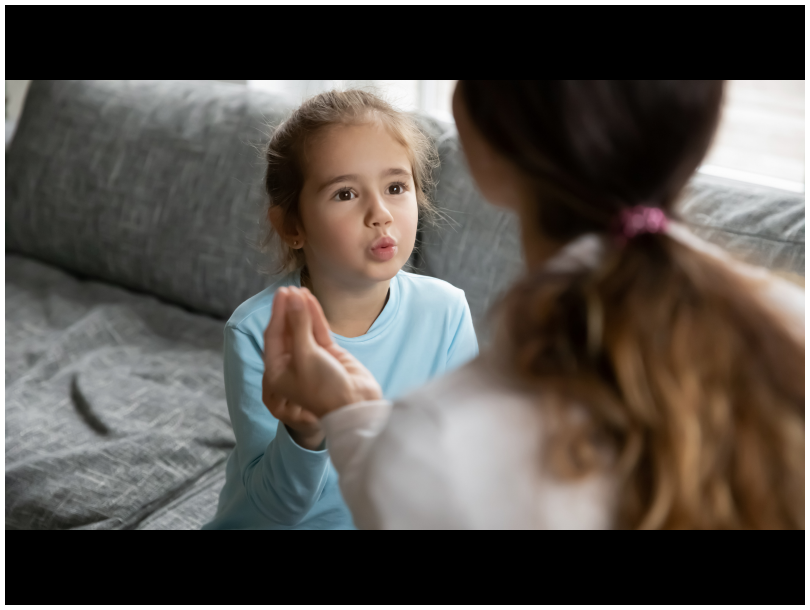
[[5, 255, 234, 529]]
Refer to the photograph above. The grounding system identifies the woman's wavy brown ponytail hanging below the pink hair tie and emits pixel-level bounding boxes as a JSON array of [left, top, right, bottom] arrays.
[[505, 235, 805, 529]]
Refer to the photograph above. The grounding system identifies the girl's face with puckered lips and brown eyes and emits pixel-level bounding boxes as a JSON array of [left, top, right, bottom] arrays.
[[299, 122, 418, 286]]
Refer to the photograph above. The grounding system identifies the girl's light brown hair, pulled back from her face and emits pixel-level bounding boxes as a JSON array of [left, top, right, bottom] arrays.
[[262, 89, 438, 271]]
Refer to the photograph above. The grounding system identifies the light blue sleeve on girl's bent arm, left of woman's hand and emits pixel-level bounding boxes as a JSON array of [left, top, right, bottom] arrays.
[[225, 325, 329, 525]]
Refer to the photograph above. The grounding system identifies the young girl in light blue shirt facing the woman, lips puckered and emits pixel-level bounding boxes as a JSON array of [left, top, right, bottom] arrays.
[[206, 91, 478, 529]]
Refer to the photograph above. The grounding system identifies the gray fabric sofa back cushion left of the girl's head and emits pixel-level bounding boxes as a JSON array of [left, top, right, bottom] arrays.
[[5, 81, 288, 317]]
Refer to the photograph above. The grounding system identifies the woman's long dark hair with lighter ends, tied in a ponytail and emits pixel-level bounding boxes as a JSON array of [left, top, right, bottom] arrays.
[[459, 81, 805, 528]]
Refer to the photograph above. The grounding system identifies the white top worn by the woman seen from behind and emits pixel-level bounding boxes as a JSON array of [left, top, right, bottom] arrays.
[[322, 225, 805, 529]]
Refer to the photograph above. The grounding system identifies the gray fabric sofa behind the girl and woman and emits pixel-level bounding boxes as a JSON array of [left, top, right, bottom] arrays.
[[5, 81, 805, 529]]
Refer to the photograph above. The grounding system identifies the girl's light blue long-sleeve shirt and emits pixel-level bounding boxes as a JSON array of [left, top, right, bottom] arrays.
[[204, 271, 478, 529]]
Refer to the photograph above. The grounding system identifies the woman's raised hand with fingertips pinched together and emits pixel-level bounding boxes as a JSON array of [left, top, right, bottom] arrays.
[[263, 288, 382, 418]]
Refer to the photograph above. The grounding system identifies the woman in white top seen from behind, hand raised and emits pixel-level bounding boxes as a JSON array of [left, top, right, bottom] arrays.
[[264, 81, 805, 529]]
